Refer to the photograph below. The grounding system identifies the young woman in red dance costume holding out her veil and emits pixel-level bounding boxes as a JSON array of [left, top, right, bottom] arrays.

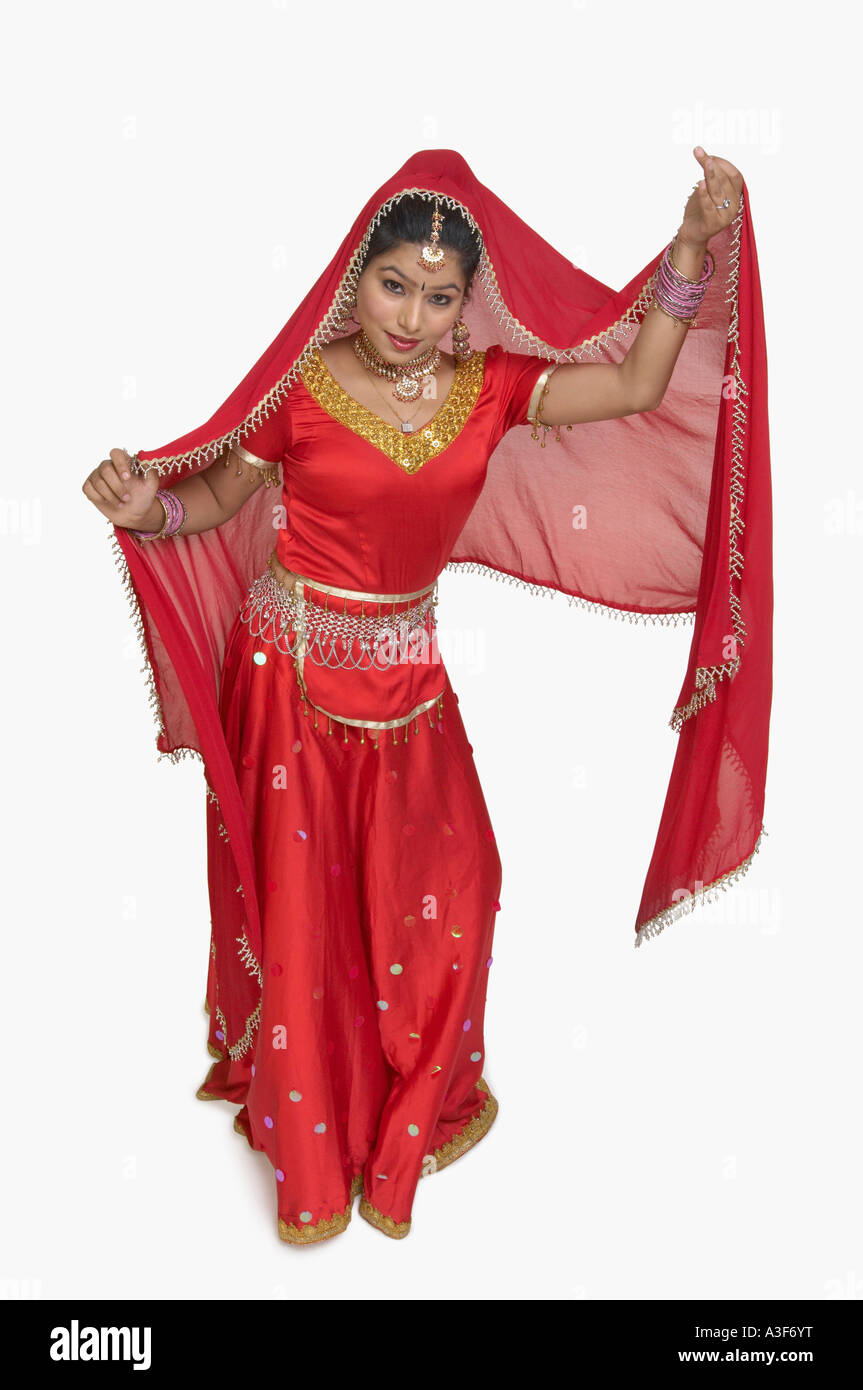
[[83, 147, 771, 1244]]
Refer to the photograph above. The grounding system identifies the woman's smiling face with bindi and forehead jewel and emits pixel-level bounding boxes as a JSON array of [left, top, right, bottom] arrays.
[[356, 242, 464, 363]]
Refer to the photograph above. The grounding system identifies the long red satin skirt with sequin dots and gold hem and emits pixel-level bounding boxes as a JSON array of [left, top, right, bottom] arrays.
[[197, 569, 502, 1244]]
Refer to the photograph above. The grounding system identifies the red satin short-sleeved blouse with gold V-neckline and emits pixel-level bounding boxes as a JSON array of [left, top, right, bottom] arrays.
[[230, 343, 548, 724]]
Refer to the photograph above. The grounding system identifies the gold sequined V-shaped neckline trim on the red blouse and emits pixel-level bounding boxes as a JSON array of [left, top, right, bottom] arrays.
[[302, 348, 485, 473]]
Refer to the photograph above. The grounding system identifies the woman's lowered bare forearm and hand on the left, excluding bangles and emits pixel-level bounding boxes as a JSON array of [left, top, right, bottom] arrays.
[[82, 449, 272, 535]]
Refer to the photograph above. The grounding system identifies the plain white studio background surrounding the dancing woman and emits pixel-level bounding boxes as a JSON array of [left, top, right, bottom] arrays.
[[0, 0, 863, 1300]]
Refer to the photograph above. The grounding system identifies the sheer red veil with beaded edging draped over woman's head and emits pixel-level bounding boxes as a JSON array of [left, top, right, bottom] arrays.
[[113, 150, 773, 956]]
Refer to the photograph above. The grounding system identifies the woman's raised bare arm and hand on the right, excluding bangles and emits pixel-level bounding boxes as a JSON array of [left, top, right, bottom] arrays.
[[542, 145, 743, 425]]
